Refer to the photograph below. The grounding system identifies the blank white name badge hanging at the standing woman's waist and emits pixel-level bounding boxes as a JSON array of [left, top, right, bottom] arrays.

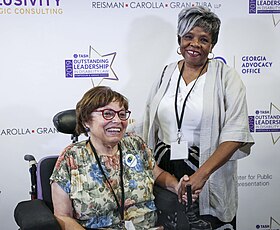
[[170, 141, 189, 160]]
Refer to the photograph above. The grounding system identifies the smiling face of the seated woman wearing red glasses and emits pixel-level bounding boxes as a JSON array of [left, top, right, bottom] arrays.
[[86, 101, 128, 148]]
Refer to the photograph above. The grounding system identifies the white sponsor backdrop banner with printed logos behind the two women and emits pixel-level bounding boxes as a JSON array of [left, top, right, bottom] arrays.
[[0, 0, 280, 230]]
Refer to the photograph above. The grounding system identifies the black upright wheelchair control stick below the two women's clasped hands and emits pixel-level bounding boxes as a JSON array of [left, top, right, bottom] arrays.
[[186, 185, 212, 230]]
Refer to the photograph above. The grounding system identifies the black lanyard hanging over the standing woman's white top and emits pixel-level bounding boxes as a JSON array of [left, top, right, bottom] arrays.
[[175, 60, 208, 144]]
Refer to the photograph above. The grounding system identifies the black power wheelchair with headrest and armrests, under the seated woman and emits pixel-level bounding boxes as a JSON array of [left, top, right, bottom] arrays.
[[14, 109, 211, 230]]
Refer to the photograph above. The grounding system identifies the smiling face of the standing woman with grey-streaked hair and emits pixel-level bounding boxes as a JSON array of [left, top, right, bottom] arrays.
[[180, 26, 213, 67]]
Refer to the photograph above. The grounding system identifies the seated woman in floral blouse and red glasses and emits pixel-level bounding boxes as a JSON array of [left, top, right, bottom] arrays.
[[15, 86, 210, 230]]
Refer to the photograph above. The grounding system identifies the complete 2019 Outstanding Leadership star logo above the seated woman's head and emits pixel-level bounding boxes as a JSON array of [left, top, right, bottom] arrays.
[[65, 46, 118, 80]]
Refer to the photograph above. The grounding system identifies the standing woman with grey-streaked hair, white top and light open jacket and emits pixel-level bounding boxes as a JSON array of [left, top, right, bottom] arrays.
[[143, 6, 254, 229]]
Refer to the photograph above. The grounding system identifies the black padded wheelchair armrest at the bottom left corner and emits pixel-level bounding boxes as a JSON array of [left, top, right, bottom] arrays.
[[14, 200, 61, 230]]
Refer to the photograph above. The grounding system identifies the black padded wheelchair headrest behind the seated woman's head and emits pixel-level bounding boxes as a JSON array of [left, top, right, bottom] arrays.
[[53, 109, 76, 135]]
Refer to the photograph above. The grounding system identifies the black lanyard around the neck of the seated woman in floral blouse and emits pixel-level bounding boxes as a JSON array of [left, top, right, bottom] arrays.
[[88, 139, 124, 222]]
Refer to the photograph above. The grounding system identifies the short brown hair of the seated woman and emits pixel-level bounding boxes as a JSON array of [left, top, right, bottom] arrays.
[[76, 86, 128, 136]]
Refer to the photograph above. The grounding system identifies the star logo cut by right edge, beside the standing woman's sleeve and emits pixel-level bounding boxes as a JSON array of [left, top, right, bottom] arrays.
[[249, 103, 280, 144]]
